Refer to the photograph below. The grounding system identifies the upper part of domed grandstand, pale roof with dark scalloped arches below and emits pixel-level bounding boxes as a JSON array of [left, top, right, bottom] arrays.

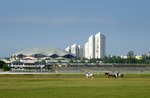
[[11, 48, 75, 60]]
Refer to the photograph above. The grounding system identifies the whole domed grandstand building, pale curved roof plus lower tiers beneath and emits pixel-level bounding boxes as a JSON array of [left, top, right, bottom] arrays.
[[10, 48, 75, 70]]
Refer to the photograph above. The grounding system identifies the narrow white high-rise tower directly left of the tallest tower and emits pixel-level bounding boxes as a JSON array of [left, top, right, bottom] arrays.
[[88, 35, 95, 59]]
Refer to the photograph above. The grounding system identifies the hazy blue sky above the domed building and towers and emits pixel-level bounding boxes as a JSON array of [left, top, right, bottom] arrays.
[[0, 0, 150, 57]]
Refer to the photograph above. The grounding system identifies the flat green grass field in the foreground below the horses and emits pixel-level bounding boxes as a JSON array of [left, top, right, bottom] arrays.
[[0, 74, 150, 98]]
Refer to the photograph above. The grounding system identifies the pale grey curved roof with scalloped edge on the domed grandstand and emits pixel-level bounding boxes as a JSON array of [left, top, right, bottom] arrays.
[[13, 48, 75, 57]]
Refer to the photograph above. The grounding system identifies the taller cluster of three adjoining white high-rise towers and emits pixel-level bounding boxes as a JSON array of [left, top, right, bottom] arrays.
[[85, 32, 106, 59]]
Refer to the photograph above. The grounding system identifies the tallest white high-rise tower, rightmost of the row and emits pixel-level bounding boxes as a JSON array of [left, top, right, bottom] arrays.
[[95, 32, 106, 58]]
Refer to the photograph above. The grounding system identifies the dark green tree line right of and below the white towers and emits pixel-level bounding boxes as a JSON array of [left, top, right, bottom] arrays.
[[71, 51, 150, 64]]
